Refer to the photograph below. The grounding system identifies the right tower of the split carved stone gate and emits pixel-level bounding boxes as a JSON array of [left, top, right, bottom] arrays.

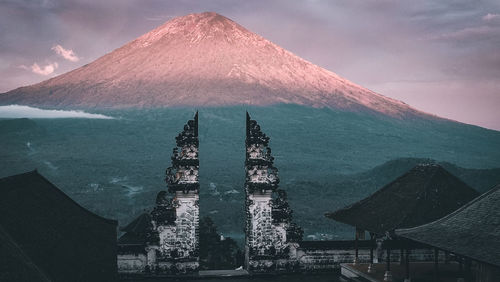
[[245, 113, 303, 272]]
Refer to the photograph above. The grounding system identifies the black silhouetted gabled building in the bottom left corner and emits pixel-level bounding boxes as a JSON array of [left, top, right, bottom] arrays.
[[0, 171, 117, 281]]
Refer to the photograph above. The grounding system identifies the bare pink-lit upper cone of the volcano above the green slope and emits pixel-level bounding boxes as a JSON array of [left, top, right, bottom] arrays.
[[0, 12, 426, 117]]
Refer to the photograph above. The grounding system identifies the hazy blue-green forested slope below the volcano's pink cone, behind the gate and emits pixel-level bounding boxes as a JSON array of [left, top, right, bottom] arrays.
[[0, 105, 500, 239]]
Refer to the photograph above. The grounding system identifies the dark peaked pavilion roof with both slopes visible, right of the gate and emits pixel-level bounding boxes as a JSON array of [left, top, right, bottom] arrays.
[[326, 164, 479, 234]]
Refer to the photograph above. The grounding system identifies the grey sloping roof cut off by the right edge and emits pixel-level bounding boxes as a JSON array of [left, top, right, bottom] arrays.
[[396, 184, 500, 266]]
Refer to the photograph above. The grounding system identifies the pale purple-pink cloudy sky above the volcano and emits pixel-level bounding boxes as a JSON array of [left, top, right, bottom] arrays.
[[0, 0, 500, 130]]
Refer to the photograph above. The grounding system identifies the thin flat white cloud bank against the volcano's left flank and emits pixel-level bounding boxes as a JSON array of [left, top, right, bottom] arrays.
[[0, 105, 114, 119]]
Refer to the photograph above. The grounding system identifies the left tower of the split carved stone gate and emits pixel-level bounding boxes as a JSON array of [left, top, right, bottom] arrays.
[[156, 113, 200, 266]]
